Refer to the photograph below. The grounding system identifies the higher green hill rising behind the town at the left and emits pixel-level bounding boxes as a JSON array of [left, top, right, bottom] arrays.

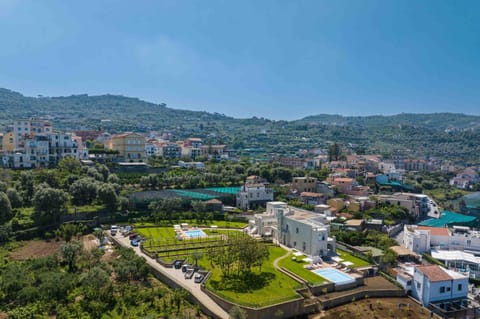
[[0, 88, 239, 130]]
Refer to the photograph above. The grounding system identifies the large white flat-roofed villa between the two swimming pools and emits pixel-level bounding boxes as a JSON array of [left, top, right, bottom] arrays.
[[250, 202, 335, 257]]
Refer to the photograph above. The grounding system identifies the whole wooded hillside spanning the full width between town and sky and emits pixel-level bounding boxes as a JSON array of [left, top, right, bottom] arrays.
[[0, 89, 480, 163]]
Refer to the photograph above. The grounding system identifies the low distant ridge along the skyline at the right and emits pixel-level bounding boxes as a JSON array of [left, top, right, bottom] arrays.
[[298, 113, 480, 131]]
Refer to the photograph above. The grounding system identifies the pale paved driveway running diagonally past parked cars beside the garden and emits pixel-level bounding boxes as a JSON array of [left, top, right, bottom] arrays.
[[108, 232, 230, 319]]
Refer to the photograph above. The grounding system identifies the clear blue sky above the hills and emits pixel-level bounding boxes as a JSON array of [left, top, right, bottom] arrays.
[[0, 0, 480, 119]]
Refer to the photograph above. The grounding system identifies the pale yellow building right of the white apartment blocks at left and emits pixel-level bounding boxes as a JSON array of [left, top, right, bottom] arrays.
[[105, 132, 145, 162]]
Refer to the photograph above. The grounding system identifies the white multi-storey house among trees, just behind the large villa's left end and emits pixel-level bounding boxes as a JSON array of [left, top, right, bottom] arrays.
[[236, 176, 273, 210]]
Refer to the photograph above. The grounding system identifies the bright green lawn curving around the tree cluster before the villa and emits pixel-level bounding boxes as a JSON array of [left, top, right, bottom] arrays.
[[199, 246, 302, 307]]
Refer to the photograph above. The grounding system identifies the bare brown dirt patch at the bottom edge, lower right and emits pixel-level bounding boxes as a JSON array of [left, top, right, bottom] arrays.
[[308, 298, 437, 319]]
